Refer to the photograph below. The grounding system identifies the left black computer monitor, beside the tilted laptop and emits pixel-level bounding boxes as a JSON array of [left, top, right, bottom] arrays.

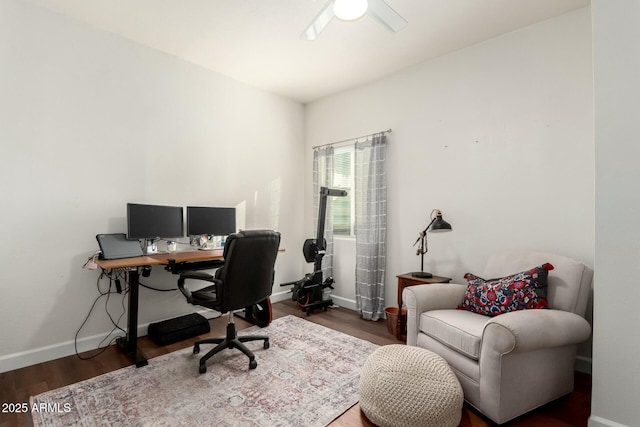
[[127, 203, 184, 240]]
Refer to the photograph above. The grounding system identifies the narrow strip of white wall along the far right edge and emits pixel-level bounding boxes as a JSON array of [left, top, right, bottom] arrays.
[[589, 0, 640, 427]]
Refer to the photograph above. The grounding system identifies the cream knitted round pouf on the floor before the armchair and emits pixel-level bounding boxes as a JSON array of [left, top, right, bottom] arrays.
[[360, 344, 464, 427]]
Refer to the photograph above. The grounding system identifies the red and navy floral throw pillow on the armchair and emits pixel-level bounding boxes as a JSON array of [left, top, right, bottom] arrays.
[[458, 263, 554, 316]]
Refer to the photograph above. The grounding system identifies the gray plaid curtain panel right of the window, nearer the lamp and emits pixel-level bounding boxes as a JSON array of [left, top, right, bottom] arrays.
[[354, 134, 387, 321]]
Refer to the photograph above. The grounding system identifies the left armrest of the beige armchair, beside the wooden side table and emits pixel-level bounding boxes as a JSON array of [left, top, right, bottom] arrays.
[[402, 283, 467, 345]]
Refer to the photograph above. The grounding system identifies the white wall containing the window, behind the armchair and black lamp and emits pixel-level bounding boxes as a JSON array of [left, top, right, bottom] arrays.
[[305, 8, 594, 354]]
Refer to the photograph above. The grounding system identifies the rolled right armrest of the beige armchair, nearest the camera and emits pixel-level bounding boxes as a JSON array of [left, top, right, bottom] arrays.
[[481, 309, 591, 354]]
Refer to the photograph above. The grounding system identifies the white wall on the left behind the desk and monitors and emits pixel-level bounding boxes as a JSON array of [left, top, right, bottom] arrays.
[[0, 0, 304, 371]]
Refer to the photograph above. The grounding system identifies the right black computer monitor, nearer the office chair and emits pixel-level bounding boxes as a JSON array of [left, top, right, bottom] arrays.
[[187, 206, 236, 236]]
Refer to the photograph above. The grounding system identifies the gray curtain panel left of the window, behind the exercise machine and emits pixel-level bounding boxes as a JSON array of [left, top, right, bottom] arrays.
[[312, 146, 334, 279]]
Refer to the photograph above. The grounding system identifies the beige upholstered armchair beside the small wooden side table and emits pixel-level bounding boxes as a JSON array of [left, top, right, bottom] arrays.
[[403, 251, 593, 424]]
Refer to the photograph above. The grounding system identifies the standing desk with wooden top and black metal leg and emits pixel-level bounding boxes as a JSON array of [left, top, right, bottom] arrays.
[[96, 249, 223, 368]]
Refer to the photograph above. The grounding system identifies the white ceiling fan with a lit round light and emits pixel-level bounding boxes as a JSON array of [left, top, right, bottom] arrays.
[[301, 0, 407, 40]]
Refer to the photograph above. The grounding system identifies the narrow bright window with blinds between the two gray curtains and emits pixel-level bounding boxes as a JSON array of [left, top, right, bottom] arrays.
[[332, 145, 355, 236]]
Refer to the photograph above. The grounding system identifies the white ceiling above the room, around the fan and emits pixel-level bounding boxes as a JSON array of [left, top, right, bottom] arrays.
[[29, 0, 590, 103]]
